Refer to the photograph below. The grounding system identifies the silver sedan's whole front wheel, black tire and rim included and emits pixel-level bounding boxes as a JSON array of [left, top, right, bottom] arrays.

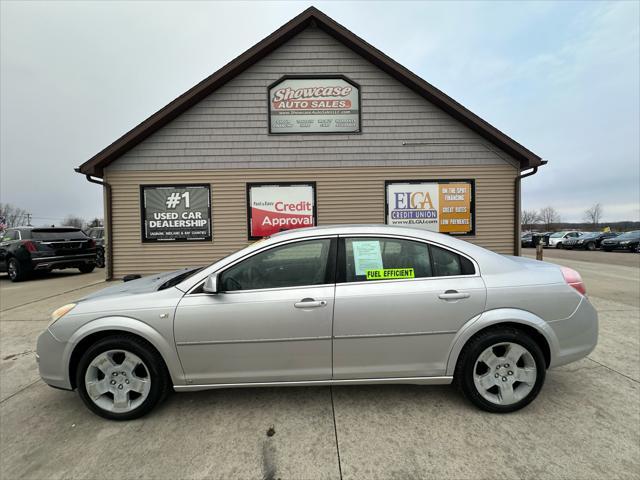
[[76, 334, 170, 420]]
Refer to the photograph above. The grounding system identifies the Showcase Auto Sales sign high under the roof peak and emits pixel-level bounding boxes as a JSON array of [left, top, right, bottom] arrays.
[[269, 77, 360, 133]]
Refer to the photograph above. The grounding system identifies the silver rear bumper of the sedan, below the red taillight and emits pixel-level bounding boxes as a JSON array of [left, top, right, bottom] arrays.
[[548, 297, 598, 367]]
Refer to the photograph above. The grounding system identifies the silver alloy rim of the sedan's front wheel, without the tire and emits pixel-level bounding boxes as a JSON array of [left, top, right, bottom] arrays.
[[84, 350, 151, 413]]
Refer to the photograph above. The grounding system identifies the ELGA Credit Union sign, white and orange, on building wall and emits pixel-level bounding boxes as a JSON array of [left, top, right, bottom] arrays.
[[386, 180, 475, 235]]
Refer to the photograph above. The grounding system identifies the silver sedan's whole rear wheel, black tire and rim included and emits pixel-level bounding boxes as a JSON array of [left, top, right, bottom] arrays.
[[454, 327, 546, 413]]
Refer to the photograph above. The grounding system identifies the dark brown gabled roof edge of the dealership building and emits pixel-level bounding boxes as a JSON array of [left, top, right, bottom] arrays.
[[76, 7, 546, 177]]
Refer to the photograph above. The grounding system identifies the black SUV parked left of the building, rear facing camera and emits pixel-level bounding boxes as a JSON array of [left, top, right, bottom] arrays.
[[0, 227, 96, 282]]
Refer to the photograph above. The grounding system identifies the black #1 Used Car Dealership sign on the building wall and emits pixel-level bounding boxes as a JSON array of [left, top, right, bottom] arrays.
[[140, 185, 211, 242]]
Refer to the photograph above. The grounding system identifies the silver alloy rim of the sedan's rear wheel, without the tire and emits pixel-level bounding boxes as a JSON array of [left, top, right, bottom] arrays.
[[473, 342, 538, 405]]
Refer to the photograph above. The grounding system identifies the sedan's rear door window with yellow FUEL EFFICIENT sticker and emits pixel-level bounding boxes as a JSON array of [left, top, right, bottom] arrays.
[[345, 238, 431, 282]]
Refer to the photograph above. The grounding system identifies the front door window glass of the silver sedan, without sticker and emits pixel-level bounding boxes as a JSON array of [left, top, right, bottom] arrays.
[[220, 239, 333, 292]]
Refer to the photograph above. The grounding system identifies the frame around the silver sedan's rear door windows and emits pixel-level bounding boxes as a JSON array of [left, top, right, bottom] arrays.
[[335, 233, 481, 285]]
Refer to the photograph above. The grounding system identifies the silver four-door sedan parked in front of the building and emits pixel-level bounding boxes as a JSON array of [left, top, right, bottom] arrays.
[[37, 225, 598, 419]]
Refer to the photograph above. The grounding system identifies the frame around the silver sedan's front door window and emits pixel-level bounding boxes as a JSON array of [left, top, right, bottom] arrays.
[[187, 235, 338, 296]]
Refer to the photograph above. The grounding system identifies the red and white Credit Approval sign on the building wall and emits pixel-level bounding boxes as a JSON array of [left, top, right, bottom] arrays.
[[247, 182, 316, 239]]
